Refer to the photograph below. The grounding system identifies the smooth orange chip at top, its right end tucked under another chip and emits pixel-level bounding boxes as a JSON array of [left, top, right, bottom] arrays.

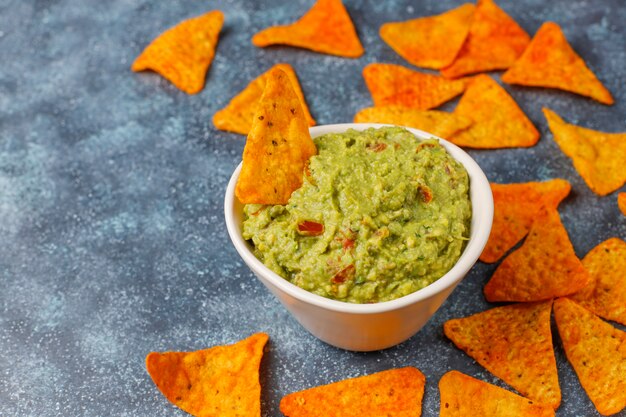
[[380, 3, 474, 69]]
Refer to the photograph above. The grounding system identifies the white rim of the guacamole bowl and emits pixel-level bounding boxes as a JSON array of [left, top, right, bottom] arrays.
[[224, 123, 494, 314]]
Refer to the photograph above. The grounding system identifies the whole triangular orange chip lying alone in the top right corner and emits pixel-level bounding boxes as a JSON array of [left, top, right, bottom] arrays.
[[502, 22, 613, 104]]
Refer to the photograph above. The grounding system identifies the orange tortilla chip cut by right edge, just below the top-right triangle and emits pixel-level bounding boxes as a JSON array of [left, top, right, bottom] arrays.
[[543, 108, 626, 195]]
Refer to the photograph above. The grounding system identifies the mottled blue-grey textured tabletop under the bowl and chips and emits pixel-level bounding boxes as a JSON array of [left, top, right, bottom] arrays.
[[0, 0, 626, 417]]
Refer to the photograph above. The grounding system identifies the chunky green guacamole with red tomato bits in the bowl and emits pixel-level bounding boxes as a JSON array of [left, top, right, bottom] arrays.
[[243, 127, 471, 303]]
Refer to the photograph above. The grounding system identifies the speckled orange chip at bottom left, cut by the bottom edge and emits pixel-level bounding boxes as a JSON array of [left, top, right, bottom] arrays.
[[146, 333, 268, 417]]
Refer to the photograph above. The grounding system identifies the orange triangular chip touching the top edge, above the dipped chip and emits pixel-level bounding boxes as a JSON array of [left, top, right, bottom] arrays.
[[252, 0, 364, 58]]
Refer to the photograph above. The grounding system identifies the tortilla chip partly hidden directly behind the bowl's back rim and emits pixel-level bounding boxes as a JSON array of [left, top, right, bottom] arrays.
[[354, 106, 472, 138]]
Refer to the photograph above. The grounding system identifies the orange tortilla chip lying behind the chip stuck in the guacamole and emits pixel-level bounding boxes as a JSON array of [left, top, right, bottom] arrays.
[[213, 64, 315, 135]]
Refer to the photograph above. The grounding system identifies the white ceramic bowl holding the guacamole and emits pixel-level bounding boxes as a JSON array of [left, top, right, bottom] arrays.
[[224, 123, 493, 351]]
